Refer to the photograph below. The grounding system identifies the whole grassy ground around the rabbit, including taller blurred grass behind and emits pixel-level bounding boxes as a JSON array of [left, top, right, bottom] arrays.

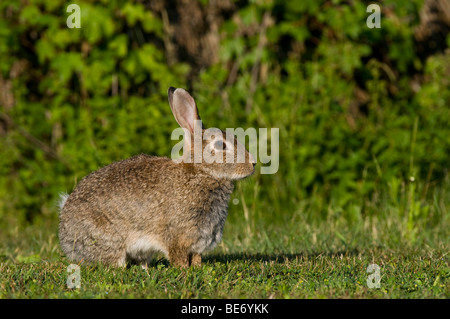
[[0, 183, 450, 298]]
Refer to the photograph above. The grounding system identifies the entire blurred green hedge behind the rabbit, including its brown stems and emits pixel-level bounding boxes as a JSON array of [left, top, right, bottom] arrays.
[[0, 0, 450, 250]]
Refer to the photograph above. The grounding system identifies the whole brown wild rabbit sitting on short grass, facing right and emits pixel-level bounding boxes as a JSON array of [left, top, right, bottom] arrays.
[[59, 87, 256, 268]]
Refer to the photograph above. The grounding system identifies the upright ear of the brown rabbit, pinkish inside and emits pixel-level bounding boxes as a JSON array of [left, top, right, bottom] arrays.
[[167, 87, 203, 134]]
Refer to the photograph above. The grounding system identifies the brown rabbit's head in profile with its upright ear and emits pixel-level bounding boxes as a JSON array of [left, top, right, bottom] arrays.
[[168, 87, 256, 180]]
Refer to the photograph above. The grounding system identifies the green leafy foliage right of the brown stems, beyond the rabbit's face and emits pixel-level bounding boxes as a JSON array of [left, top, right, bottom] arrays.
[[195, 1, 450, 228]]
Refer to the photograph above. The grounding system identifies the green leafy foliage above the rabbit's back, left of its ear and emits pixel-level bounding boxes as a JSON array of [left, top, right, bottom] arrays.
[[0, 1, 188, 224]]
